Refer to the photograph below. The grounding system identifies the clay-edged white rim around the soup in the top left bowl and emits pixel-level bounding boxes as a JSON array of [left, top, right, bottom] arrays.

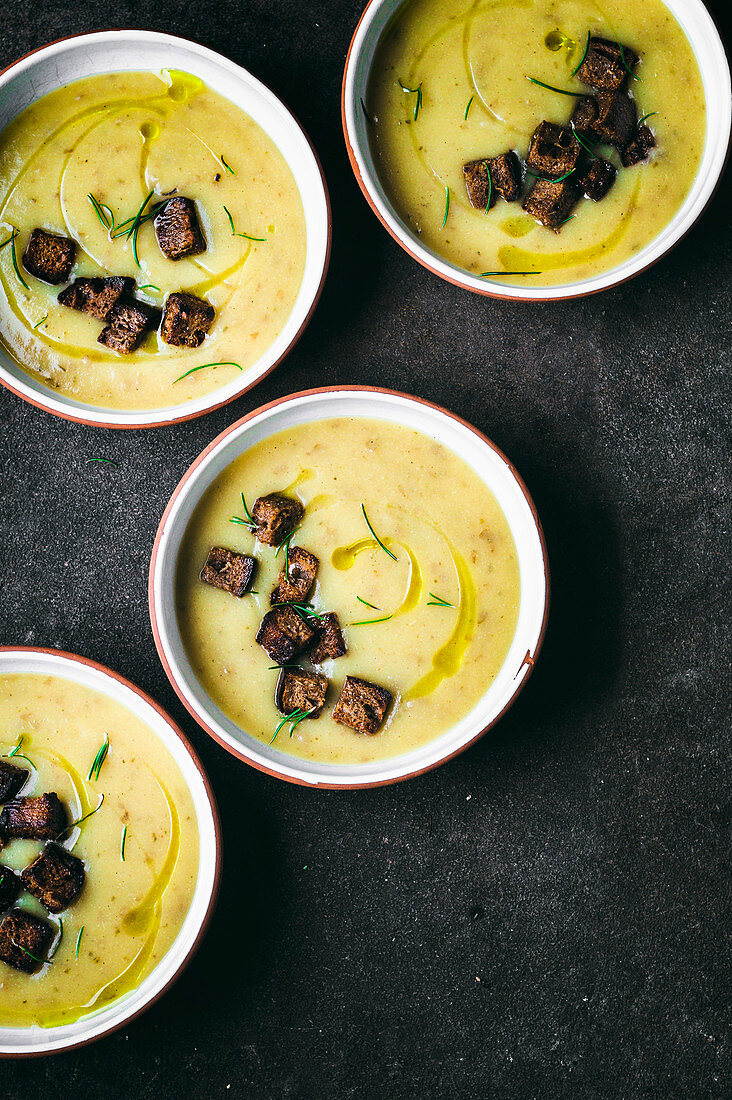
[[0, 28, 332, 429]]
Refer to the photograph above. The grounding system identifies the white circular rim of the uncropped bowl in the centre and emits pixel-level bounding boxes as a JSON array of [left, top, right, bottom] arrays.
[[148, 386, 550, 790]]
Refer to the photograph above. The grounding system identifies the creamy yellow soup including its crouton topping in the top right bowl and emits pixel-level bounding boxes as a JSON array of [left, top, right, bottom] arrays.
[[363, 0, 706, 286]]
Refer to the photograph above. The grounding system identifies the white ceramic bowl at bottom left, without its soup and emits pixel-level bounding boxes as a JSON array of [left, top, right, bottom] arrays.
[[0, 646, 221, 1057]]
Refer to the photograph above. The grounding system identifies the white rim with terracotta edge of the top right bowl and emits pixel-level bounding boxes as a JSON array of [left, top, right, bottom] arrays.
[[341, 0, 732, 301]]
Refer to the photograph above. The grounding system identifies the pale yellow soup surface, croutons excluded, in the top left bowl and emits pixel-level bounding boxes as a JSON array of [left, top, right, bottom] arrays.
[[0, 70, 306, 409]]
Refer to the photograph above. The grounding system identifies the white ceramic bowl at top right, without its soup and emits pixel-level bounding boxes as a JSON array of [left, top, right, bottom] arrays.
[[341, 0, 732, 301]]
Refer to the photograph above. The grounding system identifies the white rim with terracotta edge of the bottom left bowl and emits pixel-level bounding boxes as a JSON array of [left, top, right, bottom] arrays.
[[0, 646, 222, 1058]]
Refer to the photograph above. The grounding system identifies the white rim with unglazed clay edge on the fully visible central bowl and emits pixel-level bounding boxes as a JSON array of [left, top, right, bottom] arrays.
[[149, 386, 549, 789]]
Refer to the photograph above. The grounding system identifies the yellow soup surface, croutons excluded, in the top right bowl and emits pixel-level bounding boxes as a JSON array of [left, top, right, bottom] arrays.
[[365, 0, 707, 286]]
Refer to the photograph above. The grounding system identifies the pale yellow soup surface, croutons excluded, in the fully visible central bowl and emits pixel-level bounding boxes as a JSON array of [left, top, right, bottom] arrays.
[[177, 418, 521, 765]]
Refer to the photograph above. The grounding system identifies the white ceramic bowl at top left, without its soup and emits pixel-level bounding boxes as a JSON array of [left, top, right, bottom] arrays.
[[0, 30, 331, 428]]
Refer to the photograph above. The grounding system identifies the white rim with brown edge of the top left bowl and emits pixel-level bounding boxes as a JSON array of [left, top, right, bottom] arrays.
[[0, 28, 332, 429]]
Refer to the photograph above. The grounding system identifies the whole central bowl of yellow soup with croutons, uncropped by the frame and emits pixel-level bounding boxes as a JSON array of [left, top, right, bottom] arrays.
[[150, 387, 548, 788]]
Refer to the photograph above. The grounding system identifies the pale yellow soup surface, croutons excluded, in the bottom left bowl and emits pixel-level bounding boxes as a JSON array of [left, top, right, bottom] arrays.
[[0, 674, 198, 1027]]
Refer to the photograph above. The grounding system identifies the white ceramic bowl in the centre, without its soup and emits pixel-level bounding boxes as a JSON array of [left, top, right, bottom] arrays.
[[150, 386, 549, 788]]
